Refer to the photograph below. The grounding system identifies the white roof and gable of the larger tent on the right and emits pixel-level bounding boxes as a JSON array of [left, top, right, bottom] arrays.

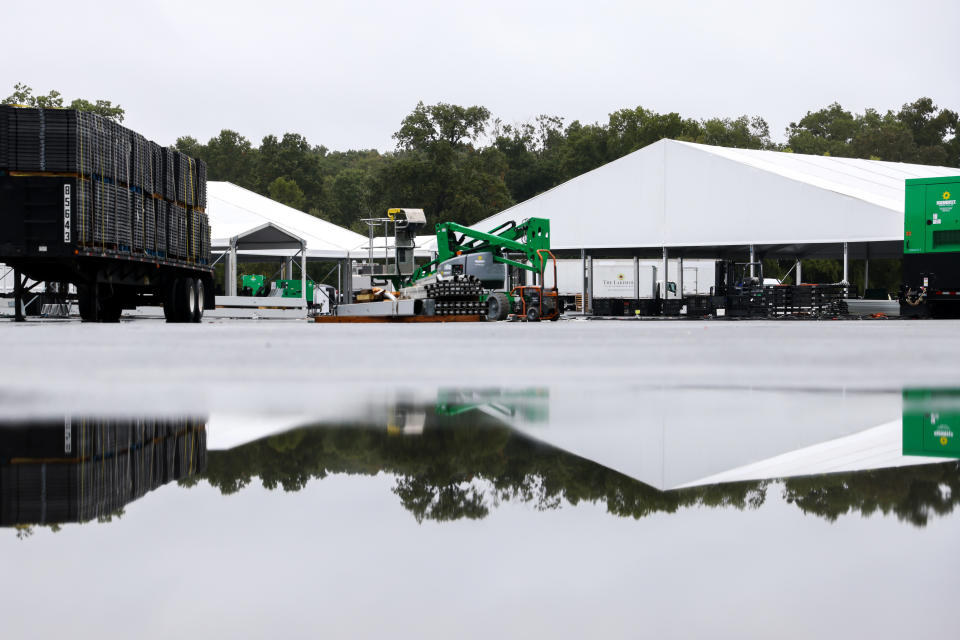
[[466, 140, 960, 257]]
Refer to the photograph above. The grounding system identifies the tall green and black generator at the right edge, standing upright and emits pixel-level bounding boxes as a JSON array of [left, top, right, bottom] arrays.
[[900, 176, 960, 316]]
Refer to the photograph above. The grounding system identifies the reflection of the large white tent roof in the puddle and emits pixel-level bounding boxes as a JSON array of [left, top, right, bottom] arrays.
[[515, 387, 909, 490]]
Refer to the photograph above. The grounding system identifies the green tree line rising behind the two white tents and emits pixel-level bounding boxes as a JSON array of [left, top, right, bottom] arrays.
[[176, 98, 960, 231]]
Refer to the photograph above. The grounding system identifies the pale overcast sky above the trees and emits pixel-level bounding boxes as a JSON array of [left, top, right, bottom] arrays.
[[0, 0, 960, 150]]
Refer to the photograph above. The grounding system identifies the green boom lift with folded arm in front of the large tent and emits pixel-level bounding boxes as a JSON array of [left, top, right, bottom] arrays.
[[402, 218, 561, 321]]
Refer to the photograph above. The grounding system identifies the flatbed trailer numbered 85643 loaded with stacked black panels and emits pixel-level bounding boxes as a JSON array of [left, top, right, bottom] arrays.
[[0, 107, 214, 322]]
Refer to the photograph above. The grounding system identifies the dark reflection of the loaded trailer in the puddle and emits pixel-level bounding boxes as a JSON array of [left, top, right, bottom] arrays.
[[0, 418, 207, 537]]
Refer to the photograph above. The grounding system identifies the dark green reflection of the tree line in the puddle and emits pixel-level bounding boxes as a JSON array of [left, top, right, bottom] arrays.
[[197, 391, 960, 526]]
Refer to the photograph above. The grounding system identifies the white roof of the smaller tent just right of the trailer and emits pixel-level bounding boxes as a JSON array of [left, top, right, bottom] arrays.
[[207, 182, 367, 259]]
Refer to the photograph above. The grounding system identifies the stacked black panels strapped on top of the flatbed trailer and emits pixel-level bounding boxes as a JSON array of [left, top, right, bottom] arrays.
[[0, 106, 210, 264]]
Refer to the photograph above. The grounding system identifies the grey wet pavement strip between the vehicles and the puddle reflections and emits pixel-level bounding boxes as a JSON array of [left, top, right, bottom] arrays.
[[0, 319, 960, 414]]
